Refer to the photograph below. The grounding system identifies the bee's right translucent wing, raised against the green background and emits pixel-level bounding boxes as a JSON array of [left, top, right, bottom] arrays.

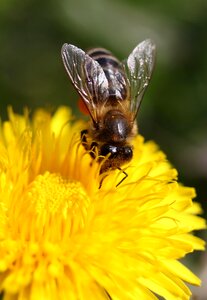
[[124, 39, 155, 119]]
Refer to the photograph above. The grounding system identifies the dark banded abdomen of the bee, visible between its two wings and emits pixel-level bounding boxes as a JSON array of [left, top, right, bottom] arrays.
[[87, 48, 128, 105]]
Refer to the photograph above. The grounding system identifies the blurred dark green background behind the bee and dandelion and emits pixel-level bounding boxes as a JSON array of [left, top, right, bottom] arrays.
[[0, 0, 207, 296]]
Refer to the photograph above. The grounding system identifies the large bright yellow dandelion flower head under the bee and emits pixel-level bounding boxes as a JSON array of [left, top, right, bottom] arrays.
[[0, 107, 205, 300]]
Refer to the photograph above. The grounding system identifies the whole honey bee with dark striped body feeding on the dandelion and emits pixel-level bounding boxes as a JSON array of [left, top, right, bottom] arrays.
[[61, 39, 155, 184]]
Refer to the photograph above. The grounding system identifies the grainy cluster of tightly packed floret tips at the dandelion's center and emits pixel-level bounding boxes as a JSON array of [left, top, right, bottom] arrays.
[[27, 172, 86, 218]]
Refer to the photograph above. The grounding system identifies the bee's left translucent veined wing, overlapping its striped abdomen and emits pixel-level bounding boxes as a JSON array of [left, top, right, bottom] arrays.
[[61, 44, 108, 124]]
